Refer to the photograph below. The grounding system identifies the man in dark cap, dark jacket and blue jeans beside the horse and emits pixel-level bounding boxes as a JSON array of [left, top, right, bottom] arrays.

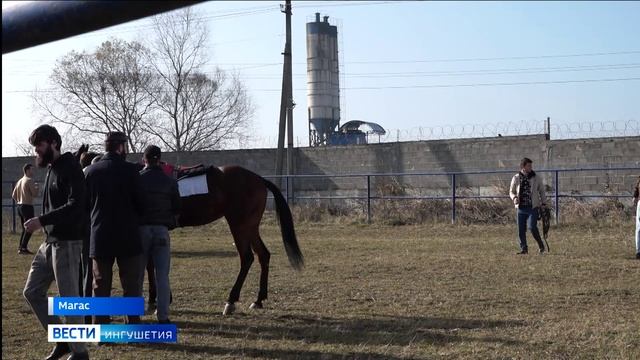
[[139, 145, 180, 324]]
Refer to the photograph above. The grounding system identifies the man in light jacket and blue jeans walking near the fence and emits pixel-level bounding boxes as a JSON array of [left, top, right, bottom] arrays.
[[509, 158, 547, 255]]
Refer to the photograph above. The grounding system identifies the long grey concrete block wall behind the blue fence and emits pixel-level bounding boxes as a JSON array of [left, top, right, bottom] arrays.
[[2, 135, 640, 203]]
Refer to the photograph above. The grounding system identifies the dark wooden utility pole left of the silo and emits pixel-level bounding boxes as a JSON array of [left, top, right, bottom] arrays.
[[276, 0, 293, 188]]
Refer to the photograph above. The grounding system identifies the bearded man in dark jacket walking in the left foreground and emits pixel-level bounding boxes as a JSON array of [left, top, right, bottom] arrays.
[[23, 125, 89, 360]]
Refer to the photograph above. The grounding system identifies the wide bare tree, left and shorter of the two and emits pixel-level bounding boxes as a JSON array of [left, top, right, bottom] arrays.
[[34, 39, 158, 152]]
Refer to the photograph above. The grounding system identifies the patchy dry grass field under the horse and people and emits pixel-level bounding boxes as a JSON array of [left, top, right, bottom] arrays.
[[2, 221, 640, 360]]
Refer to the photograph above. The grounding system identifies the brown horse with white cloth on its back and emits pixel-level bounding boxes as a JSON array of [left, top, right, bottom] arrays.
[[76, 146, 304, 315]]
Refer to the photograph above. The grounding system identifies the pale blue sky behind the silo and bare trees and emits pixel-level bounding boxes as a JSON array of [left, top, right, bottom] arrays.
[[2, 1, 640, 157]]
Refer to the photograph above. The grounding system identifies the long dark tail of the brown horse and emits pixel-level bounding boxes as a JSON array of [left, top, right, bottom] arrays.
[[262, 178, 304, 270]]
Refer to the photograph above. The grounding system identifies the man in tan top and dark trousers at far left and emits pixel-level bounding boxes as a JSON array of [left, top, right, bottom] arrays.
[[11, 164, 39, 255]]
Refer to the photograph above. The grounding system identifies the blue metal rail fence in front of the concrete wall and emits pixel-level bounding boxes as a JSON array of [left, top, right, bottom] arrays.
[[2, 167, 640, 232]]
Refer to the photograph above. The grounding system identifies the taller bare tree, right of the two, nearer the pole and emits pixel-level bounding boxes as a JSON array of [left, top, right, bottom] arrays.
[[145, 8, 253, 151]]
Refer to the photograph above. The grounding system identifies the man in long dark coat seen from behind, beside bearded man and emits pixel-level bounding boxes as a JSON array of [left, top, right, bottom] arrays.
[[86, 132, 144, 324]]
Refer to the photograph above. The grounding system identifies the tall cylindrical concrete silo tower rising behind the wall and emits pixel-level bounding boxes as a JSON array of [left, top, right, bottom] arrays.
[[307, 13, 340, 146]]
